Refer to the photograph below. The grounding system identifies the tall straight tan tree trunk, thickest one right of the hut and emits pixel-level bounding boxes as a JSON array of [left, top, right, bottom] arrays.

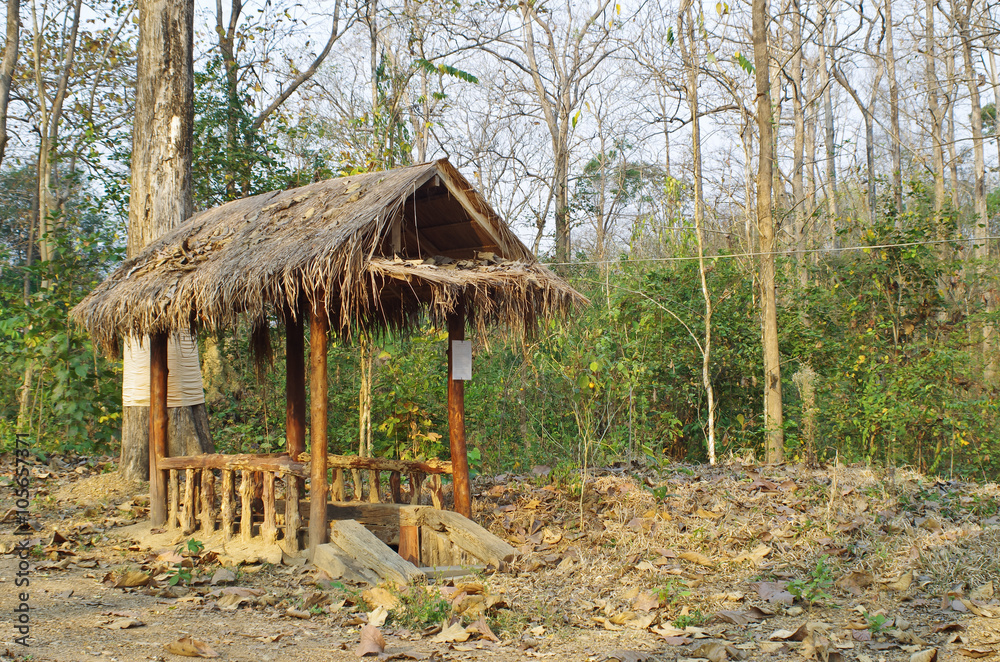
[[753, 0, 785, 463]]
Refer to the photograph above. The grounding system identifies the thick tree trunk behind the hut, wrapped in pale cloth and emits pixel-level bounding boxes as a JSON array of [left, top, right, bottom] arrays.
[[119, 0, 214, 480]]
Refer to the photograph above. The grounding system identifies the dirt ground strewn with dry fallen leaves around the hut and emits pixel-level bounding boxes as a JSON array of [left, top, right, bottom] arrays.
[[0, 457, 1000, 662]]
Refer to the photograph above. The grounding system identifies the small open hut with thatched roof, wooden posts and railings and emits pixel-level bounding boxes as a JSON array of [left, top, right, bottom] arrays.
[[72, 160, 584, 564]]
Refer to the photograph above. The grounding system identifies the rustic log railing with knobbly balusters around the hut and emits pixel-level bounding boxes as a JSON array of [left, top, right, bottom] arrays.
[[159, 454, 452, 551]]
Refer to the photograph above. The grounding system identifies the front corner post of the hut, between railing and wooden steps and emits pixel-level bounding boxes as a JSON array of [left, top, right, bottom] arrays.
[[309, 298, 330, 550]]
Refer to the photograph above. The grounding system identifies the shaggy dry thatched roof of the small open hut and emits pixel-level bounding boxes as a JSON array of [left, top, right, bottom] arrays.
[[72, 160, 585, 354]]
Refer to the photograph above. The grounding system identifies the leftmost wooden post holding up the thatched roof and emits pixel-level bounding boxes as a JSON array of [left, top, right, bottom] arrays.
[[149, 333, 167, 527]]
